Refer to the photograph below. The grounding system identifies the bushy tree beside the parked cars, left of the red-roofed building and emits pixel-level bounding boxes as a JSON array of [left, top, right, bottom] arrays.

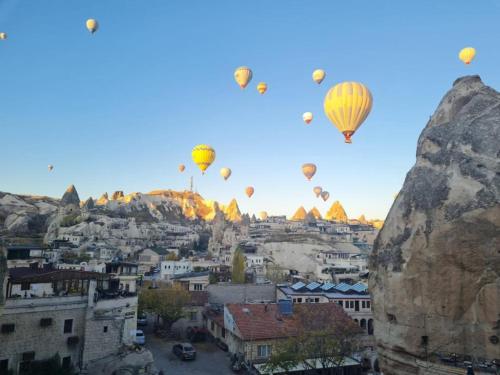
[[139, 285, 191, 331]]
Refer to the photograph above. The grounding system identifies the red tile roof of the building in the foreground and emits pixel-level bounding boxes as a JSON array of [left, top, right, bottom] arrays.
[[226, 303, 352, 340]]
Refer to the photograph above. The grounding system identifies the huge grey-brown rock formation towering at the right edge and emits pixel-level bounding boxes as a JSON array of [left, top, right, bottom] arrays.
[[370, 76, 500, 374]]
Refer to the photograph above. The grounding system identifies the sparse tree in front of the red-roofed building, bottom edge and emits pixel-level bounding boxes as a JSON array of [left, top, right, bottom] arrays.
[[265, 304, 360, 374]]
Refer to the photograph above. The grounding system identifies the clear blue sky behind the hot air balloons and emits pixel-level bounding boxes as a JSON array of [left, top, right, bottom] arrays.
[[0, 0, 500, 218]]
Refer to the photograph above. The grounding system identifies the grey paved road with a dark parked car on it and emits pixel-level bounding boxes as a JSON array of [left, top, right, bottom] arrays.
[[146, 334, 233, 375]]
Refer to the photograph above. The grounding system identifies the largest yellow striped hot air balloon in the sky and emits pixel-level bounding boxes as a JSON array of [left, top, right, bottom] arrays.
[[324, 82, 373, 143]]
